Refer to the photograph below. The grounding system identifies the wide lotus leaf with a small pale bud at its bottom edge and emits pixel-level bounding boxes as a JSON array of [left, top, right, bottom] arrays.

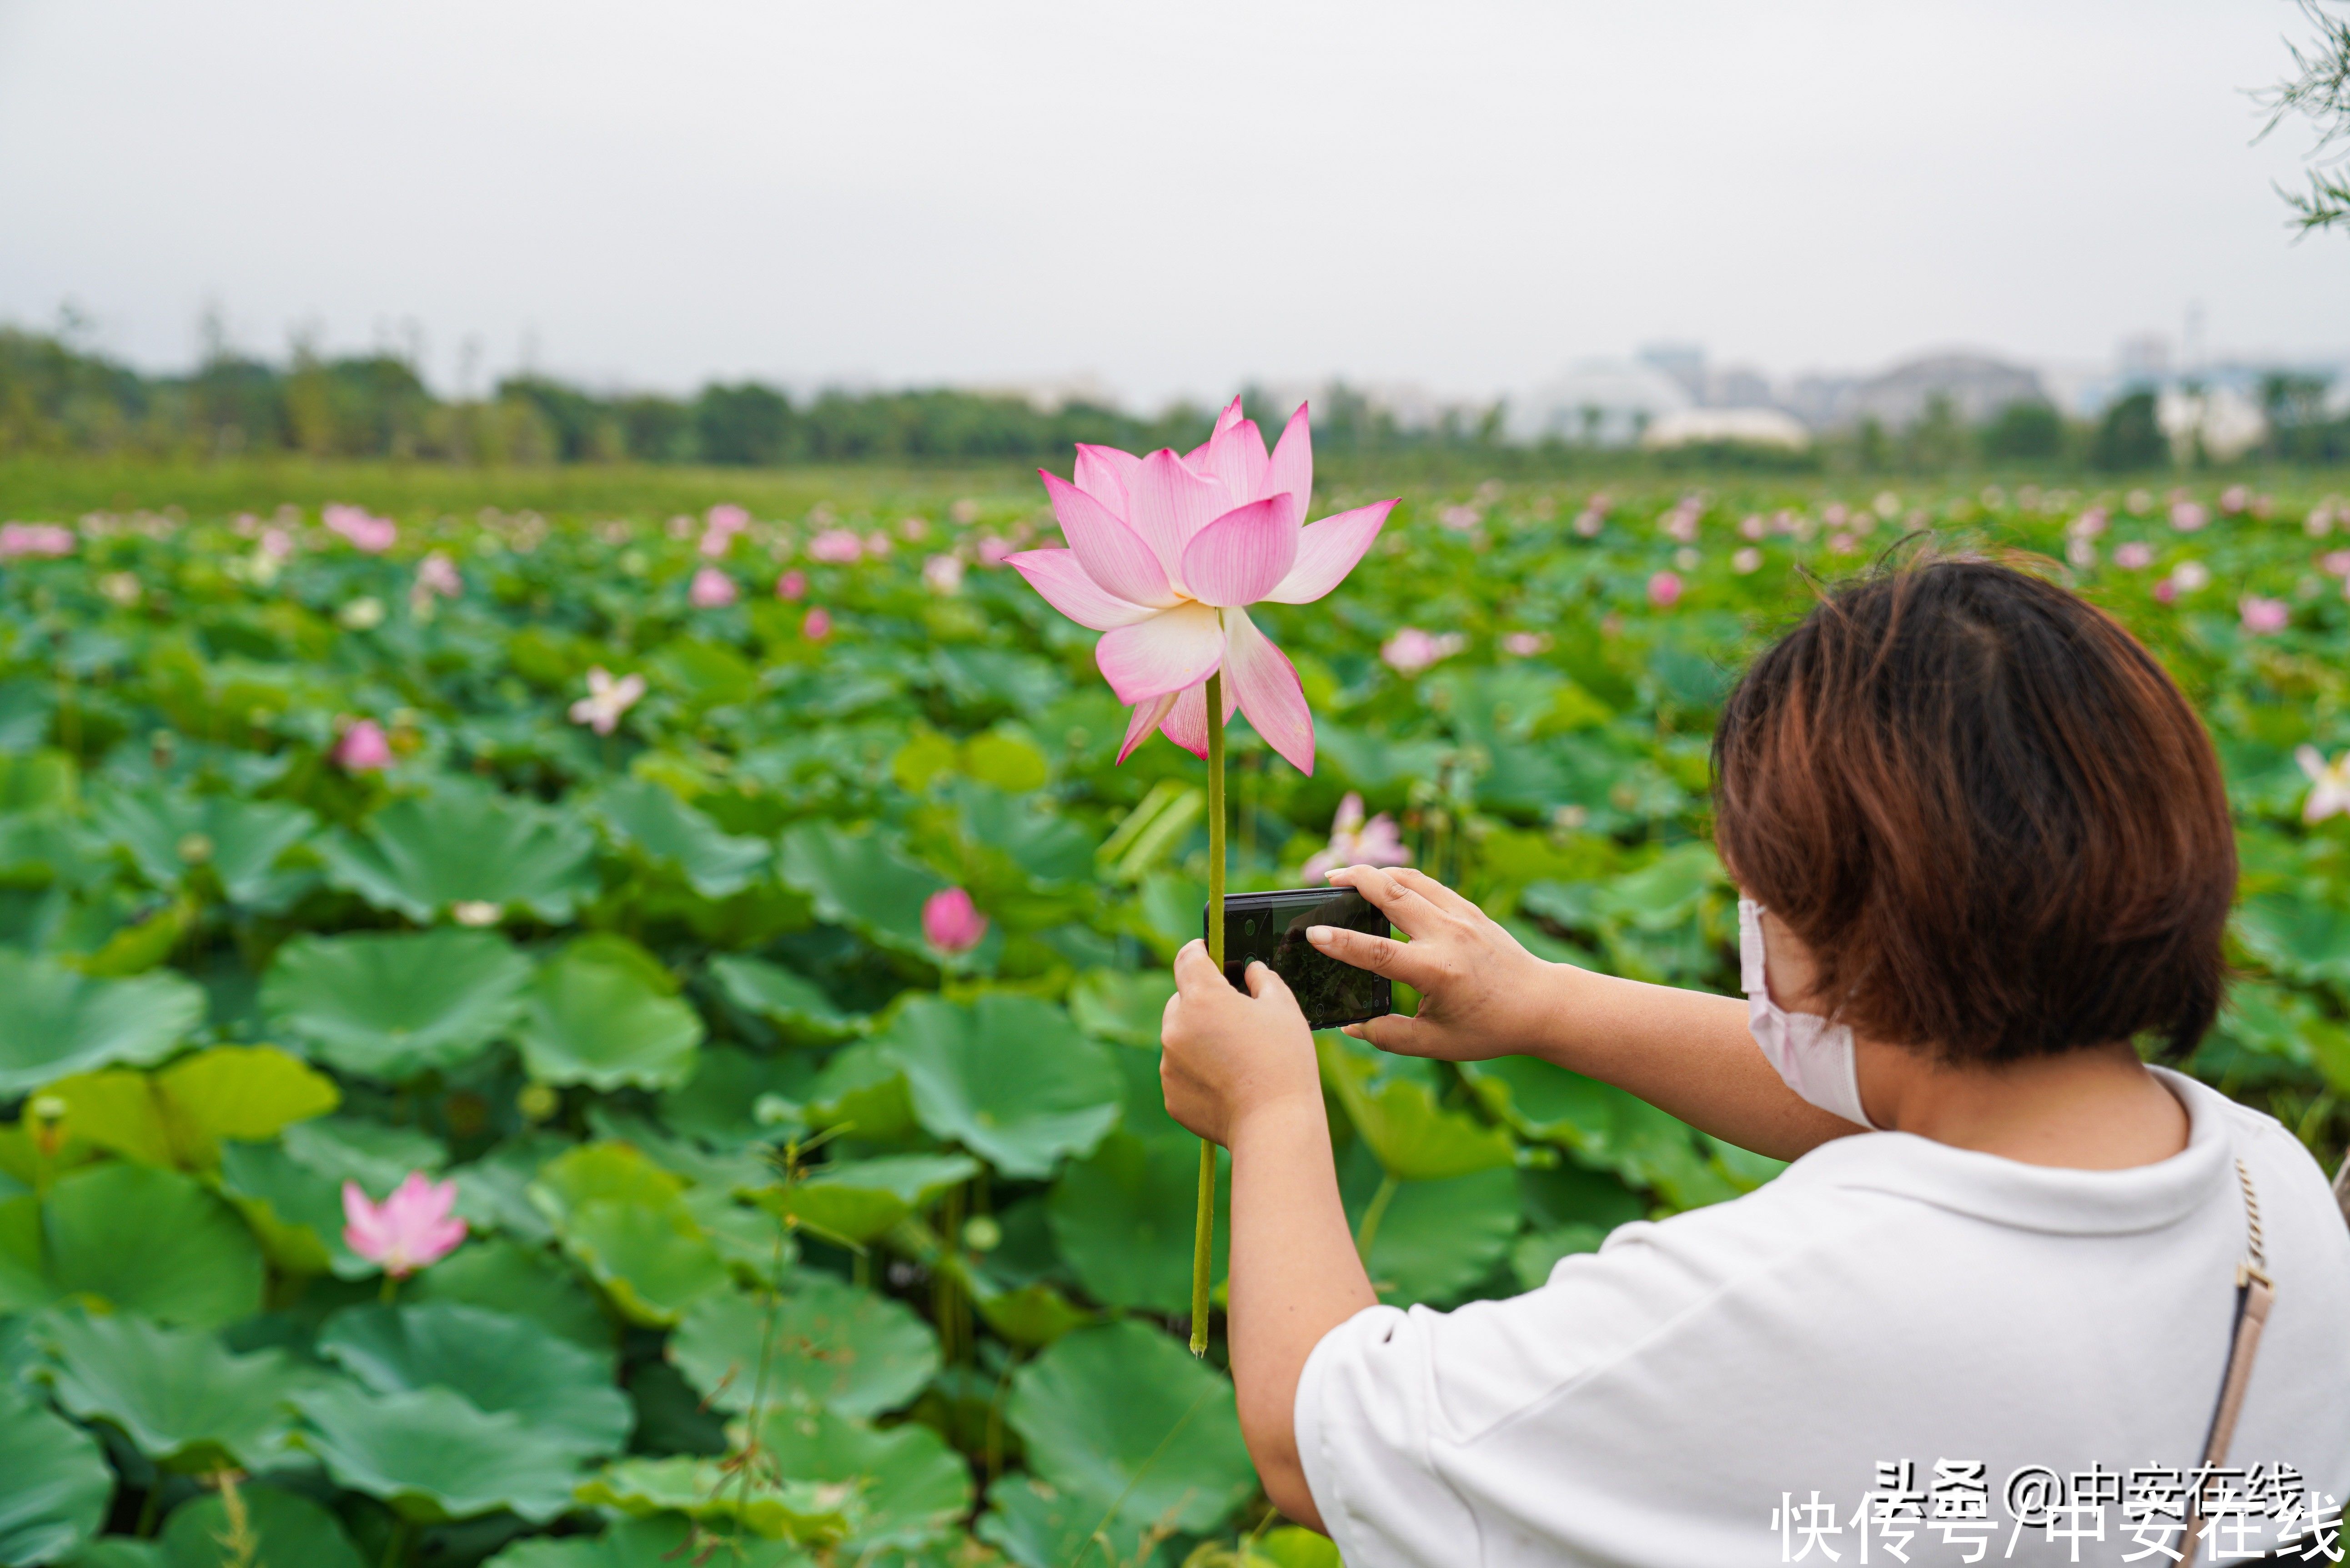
[[317, 788, 597, 924]]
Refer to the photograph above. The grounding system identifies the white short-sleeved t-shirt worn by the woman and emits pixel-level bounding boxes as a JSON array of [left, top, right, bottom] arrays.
[[1297, 1074, 2350, 1568]]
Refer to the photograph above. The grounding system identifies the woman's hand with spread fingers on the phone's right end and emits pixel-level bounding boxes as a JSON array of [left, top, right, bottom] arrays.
[[1306, 865, 1558, 1063]]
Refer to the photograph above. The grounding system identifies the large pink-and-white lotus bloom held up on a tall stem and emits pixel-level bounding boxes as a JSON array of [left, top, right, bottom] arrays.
[[1015, 397, 1396, 774]]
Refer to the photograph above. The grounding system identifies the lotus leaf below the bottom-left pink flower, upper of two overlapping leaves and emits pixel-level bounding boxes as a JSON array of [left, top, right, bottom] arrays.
[[317, 1302, 632, 1457]]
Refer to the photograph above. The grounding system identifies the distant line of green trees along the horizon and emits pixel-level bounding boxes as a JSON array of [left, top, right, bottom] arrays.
[[0, 327, 2350, 475]]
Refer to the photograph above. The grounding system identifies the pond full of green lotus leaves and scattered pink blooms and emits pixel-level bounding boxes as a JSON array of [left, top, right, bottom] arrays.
[[0, 477, 2350, 1568]]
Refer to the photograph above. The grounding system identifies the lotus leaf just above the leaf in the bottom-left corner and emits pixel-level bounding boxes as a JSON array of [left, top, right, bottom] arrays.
[[47, 1312, 320, 1474]]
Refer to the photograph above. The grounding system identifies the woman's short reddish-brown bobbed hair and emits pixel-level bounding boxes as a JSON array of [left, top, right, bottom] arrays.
[[1713, 557, 2235, 1063]]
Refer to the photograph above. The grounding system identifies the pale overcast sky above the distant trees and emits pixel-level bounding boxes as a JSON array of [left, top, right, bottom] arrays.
[[0, 0, 2350, 404]]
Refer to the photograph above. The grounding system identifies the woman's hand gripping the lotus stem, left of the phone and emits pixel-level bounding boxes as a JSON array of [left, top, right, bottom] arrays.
[[1159, 943, 1323, 1147]]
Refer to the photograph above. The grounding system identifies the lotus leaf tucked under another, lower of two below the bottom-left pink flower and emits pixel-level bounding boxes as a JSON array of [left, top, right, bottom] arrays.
[[294, 1385, 578, 1523]]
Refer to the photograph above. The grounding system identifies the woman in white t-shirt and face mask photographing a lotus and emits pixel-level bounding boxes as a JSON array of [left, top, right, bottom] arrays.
[[1161, 559, 2350, 1568]]
